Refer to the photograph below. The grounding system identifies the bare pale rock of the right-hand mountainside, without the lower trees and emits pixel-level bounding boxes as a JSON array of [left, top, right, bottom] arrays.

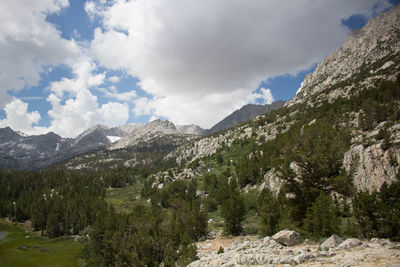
[[159, 5, 400, 195]]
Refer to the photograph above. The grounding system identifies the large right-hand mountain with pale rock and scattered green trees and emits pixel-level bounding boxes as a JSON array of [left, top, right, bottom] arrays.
[[161, 5, 400, 195]]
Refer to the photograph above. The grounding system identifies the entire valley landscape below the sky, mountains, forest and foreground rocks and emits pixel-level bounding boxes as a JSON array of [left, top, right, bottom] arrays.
[[0, 2, 400, 266]]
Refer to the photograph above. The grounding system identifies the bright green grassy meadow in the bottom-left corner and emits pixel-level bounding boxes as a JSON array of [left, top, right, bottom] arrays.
[[0, 220, 84, 267]]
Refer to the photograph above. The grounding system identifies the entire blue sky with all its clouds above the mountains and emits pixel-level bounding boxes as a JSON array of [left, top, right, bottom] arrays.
[[0, 0, 400, 137]]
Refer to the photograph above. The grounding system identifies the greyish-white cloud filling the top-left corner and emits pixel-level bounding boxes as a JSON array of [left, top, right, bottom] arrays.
[[0, 0, 79, 107]]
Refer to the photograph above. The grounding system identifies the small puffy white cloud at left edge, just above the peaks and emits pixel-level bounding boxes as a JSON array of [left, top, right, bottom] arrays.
[[0, 99, 46, 134]]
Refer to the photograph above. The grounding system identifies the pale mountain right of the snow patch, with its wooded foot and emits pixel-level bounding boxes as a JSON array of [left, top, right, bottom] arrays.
[[59, 119, 204, 170]]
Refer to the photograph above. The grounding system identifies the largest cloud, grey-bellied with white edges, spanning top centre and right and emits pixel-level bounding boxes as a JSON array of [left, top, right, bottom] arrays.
[[86, 0, 388, 127]]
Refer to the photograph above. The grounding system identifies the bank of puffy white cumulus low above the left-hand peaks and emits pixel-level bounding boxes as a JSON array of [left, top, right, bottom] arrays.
[[0, 56, 130, 137]]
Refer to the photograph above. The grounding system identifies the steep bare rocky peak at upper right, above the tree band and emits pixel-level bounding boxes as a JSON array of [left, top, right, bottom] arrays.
[[286, 5, 400, 106]]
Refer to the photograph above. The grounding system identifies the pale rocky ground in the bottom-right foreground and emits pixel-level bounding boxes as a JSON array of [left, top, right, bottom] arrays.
[[189, 237, 400, 267]]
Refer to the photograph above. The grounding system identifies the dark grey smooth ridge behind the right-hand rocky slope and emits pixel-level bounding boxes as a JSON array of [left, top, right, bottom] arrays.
[[204, 100, 285, 135]]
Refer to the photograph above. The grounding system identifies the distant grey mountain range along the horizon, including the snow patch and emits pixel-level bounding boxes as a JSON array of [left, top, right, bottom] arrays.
[[0, 101, 284, 170]]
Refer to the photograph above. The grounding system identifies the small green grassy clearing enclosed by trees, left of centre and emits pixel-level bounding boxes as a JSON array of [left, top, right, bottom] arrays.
[[106, 183, 147, 213]]
